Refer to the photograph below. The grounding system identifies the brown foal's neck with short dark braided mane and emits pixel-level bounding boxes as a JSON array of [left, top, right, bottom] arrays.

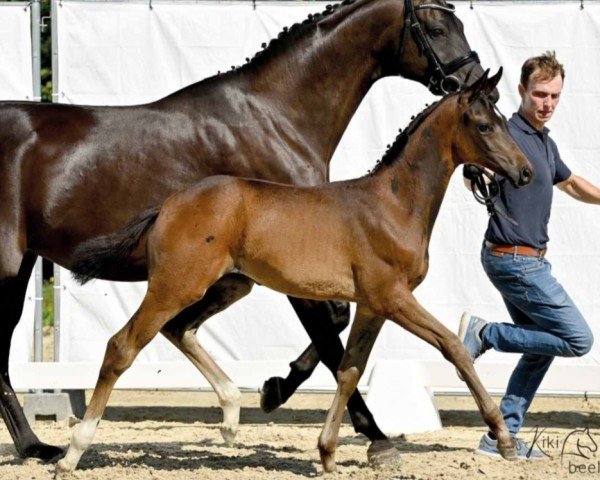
[[374, 97, 458, 240]]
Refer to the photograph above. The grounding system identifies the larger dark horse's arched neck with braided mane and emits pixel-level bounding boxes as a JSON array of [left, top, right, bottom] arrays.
[[164, 0, 404, 172]]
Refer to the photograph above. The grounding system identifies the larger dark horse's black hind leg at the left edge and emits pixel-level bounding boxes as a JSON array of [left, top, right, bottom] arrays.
[[0, 253, 62, 460]]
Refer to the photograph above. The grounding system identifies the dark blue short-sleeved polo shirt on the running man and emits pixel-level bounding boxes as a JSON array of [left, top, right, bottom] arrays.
[[485, 113, 571, 249]]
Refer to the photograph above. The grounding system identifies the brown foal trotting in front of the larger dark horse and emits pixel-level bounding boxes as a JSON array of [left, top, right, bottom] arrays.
[[64, 71, 532, 477]]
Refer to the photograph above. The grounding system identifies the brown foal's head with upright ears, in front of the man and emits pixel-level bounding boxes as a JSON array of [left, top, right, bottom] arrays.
[[452, 69, 533, 186]]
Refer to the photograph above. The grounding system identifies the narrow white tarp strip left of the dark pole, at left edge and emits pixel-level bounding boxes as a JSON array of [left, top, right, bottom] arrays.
[[0, 2, 35, 362]]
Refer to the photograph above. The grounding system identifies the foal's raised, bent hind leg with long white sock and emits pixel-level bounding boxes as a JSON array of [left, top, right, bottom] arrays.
[[162, 274, 253, 444]]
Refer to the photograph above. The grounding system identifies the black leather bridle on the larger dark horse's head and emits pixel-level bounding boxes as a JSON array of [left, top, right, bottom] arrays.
[[398, 0, 479, 95]]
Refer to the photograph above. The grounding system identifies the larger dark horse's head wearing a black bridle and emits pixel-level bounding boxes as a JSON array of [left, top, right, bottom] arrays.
[[396, 0, 490, 100]]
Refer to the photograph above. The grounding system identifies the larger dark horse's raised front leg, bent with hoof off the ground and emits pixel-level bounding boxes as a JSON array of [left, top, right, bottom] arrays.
[[260, 297, 350, 413]]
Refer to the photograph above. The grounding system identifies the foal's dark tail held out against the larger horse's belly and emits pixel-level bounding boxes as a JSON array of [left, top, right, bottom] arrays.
[[69, 205, 160, 284]]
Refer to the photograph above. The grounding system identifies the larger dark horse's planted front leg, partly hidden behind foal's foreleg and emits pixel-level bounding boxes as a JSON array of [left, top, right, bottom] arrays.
[[290, 297, 398, 462]]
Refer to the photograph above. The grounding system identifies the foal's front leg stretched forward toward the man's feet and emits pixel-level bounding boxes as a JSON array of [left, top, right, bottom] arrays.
[[380, 291, 516, 460]]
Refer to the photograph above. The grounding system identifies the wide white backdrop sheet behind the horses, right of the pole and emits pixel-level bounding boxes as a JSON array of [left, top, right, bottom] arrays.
[[52, 0, 600, 390]]
